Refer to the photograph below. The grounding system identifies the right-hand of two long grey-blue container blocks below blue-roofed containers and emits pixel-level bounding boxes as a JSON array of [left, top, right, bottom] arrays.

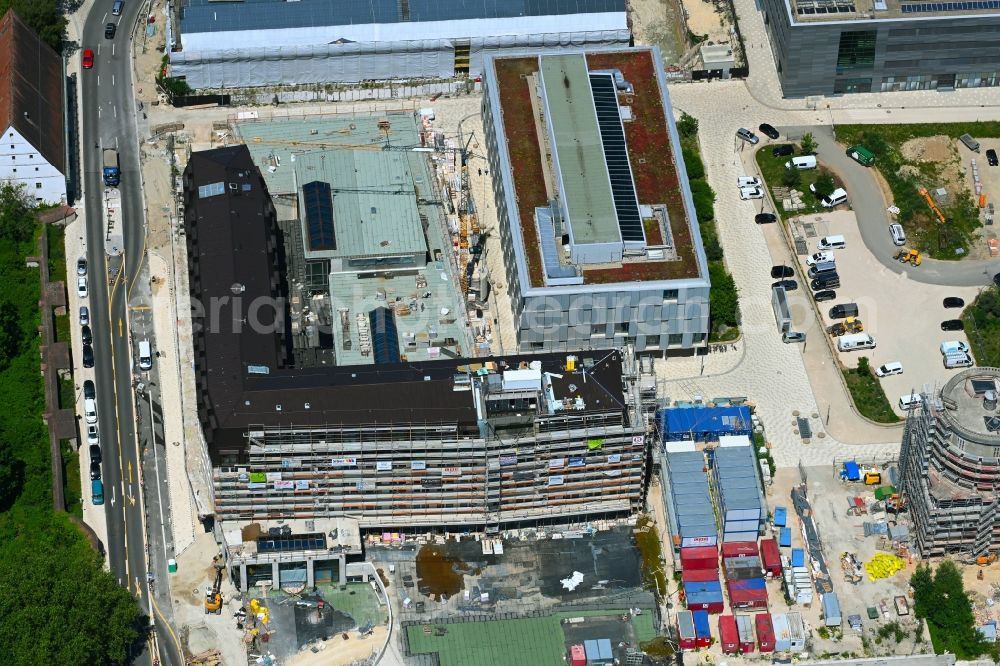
[[712, 436, 766, 543]]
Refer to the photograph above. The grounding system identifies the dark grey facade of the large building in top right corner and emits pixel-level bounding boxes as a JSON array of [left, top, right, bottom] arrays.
[[761, 0, 1000, 97]]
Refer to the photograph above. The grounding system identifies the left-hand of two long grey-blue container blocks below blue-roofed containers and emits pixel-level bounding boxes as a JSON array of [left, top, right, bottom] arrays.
[[663, 442, 718, 547]]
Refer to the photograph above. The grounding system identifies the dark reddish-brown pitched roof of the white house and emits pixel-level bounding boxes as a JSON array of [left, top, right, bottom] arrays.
[[0, 9, 66, 173]]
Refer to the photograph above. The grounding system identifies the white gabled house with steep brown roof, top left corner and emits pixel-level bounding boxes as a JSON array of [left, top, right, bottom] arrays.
[[0, 10, 66, 203]]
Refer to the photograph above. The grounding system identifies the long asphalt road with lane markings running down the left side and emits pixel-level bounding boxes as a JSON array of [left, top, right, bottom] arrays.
[[78, 0, 183, 664]]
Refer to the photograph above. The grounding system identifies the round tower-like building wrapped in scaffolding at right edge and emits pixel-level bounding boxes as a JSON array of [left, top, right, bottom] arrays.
[[899, 368, 1000, 560]]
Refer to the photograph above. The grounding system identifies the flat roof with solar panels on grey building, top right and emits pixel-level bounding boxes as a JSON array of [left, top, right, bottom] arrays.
[[785, 0, 1000, 23]]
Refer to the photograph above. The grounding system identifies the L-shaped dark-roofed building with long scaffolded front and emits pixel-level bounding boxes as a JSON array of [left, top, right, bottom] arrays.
[[184, 146, 653, 532]]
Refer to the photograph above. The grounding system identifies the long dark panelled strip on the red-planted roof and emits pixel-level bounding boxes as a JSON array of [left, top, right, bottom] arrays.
[[590, 74, 646, 242]]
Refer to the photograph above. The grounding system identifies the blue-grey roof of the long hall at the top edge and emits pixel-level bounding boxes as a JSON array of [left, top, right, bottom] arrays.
[[181, 0, 625, 33]]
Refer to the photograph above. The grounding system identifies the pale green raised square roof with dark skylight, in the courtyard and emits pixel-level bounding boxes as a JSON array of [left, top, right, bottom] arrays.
[[295, 148, 427, 259]]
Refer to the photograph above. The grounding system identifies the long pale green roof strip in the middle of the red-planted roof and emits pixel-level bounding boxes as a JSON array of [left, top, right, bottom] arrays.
[[539, 53, 621, 245]]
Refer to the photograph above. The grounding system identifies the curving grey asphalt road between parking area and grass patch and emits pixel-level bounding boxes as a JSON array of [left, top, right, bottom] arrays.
[[781, 126, 1000, 287]]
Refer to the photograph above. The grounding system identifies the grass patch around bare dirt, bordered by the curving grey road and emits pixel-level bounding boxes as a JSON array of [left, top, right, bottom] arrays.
[[837, 122, 1000, 259]]
